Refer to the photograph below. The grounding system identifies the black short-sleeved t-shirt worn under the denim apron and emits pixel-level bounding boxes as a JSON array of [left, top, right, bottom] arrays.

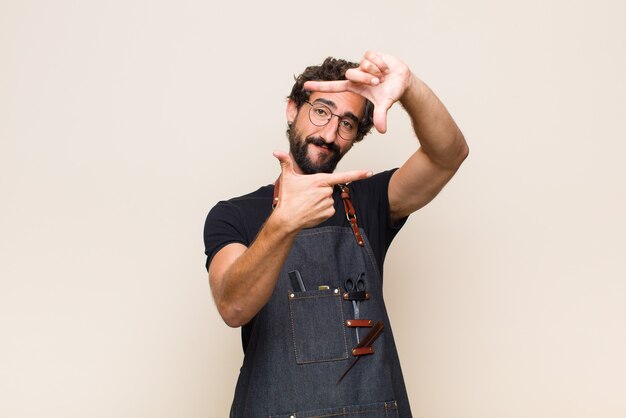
[[204, 169, 406, 275]]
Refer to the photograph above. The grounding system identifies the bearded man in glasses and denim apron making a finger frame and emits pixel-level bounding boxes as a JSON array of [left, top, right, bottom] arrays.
[[204, 51, 468, 417]]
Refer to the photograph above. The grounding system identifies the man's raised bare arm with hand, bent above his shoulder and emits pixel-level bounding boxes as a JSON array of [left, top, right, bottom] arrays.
[[305, 51, 468, 222]]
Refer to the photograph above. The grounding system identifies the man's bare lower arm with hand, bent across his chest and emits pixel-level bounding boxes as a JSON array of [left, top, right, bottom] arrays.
[[209, 152, 371, 327]]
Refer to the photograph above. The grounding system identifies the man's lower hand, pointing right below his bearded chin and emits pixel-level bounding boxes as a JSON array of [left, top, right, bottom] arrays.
[[274, 151, 372, 231]]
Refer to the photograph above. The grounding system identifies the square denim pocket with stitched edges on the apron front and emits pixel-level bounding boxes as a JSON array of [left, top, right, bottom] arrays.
[[289, 289, 348, 364]]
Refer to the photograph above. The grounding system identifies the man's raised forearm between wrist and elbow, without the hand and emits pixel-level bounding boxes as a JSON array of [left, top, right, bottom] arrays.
[[400, 74, 468, 170]]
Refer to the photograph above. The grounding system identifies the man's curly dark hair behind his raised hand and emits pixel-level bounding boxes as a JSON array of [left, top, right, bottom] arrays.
[[287, 57, 374, 142]]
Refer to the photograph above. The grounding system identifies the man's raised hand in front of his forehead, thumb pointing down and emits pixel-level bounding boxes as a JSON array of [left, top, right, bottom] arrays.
[[304, 51, 413, 133]]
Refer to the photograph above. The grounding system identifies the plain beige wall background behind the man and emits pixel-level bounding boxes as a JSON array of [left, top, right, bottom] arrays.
[[0, 0, 626, 418]]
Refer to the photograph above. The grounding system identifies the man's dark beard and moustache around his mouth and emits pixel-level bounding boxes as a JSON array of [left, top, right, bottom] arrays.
[[288, 126, 343, 174]]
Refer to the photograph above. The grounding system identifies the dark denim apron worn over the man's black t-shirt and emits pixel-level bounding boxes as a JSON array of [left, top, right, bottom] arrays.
[[231, 189, 411, 418]]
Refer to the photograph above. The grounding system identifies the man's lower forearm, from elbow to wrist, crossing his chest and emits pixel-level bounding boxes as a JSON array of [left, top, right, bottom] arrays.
[[211, 214, 297, 327]]
